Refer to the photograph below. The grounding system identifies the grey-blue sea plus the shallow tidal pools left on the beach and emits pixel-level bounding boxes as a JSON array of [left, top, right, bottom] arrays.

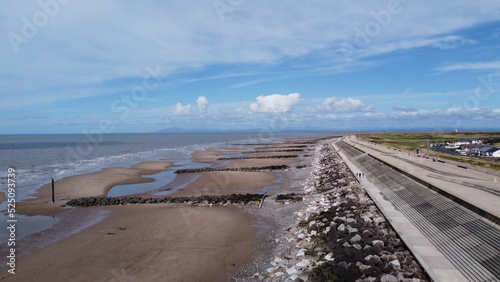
[[0, 132, 330, 268]]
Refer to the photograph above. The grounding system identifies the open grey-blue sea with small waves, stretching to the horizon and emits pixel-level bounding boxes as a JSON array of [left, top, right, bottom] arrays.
[[0, 133, 328, 201]]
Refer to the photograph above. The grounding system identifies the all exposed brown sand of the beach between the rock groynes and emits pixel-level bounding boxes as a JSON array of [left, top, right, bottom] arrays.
[[0, 140, 308, 281]]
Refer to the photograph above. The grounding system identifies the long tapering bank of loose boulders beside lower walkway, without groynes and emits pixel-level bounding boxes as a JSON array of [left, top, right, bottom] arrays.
[[251, 145, 430, 282]]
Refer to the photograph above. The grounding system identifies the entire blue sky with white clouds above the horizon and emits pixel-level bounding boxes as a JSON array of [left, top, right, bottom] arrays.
[[0, 0, 500, 134]]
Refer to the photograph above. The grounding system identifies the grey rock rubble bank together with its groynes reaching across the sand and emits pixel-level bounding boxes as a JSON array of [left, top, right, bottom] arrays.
[[58, 137, 430, 282]]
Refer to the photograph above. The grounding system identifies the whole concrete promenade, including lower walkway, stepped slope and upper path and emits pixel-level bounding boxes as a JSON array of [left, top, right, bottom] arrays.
[[332, 136, 500, 281]]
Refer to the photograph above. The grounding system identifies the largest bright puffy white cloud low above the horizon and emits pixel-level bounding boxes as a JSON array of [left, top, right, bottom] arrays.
[[249, 93, 300, 113]]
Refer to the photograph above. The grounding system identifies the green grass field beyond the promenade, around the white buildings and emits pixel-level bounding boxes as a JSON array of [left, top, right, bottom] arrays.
[[361, 132, 500, 170]]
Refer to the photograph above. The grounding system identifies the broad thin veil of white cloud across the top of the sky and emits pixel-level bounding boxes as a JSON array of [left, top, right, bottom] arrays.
[[0, 0, 500, 107]]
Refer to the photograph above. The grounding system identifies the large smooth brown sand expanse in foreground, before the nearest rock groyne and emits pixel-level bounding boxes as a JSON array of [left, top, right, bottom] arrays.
[[0, 204, 257, 281]]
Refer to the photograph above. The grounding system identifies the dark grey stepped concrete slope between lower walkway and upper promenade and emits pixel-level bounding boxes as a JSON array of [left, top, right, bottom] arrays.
[[336, 141, 500, 281]]
